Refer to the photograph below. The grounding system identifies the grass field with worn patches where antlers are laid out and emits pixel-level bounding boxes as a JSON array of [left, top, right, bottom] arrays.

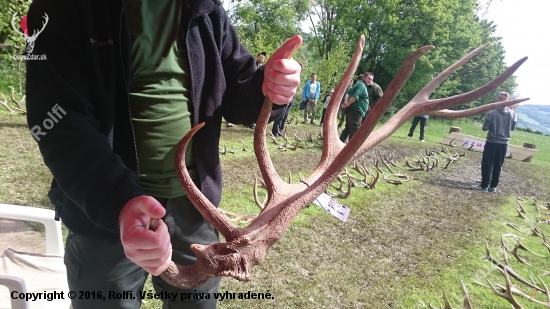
[[0, 107, 550, 309]]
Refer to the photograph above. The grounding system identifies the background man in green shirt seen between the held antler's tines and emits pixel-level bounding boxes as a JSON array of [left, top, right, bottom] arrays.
[[340, 74, 369, 143]]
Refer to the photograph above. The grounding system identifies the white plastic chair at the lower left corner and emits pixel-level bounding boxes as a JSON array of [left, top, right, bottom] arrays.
[[0, 204, 71, 309]]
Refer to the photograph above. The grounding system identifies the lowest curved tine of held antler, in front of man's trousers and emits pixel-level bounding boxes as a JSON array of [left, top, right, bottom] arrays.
[[176, 123, 239, 239]]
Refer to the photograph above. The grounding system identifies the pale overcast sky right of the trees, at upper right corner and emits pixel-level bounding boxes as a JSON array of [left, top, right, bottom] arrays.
[[485, 0, 550, 105]]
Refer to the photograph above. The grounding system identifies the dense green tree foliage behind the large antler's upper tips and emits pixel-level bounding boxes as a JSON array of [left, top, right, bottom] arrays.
[[300, 0, 516, 113]]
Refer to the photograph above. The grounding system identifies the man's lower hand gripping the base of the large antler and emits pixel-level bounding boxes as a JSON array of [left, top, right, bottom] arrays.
[[119, 196, 172, 276]]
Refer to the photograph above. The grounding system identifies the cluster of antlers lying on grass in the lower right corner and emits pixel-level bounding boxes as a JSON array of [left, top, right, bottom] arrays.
[[436, 196, 550, 309]]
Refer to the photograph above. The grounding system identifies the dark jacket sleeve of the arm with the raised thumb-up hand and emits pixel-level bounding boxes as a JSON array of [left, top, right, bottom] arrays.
[[220, 8, 284, 124]]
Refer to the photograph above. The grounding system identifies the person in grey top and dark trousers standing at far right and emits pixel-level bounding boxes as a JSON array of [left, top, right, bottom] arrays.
[[479, 92, 517, 192]]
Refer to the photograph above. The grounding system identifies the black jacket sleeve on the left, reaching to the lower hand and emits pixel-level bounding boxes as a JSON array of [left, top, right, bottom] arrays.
[[27, 0, 143, 233]]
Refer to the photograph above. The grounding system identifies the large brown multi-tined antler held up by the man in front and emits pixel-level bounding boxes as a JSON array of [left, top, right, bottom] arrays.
[[157, 36, 527, 288]]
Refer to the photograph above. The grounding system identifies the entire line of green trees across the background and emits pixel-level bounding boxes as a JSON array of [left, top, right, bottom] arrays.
[[225, 0, 517, 117]]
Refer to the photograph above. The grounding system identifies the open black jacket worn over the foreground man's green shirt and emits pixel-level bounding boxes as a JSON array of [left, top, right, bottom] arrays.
[[27, 0, 282, 238]]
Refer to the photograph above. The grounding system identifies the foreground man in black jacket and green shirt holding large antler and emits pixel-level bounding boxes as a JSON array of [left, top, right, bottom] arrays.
[[27, 0, 301, 309]]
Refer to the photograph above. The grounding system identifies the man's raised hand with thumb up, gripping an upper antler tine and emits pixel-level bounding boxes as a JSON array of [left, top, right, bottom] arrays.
[[262, 35, 302, 105]]
